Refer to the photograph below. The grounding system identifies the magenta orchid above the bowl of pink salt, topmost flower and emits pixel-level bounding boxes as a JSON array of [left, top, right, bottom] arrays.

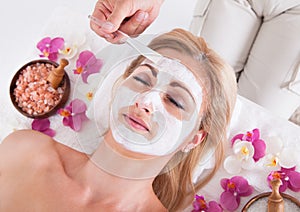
[[36, 37, 65, 61]]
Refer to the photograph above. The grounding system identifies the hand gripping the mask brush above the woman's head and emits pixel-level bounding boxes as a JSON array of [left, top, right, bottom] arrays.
[[90, 0, 163, 43]]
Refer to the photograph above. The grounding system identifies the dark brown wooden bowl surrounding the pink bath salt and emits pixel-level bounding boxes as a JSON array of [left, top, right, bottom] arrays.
[[9, 59, 70, 119]]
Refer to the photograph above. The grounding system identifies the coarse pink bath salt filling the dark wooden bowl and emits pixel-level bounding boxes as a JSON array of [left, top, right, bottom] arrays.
[[14, 63, 64, 115]]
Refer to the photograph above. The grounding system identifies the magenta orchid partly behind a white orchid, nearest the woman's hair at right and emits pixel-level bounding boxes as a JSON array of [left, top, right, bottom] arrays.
[[231, 129, 266, 162]]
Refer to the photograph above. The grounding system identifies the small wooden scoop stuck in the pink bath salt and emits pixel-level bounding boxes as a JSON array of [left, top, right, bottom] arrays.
[[47, 59, 69, 89]]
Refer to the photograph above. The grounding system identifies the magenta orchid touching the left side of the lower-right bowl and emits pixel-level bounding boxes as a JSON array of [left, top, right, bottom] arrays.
[[220, 176, 253, 211]]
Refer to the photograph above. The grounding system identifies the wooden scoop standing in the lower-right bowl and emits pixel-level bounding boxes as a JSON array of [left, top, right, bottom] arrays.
[[268, 179, 284, 212]]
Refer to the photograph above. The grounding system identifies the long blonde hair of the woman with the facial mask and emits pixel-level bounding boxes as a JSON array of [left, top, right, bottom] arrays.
[[124, 29, 237, 211]]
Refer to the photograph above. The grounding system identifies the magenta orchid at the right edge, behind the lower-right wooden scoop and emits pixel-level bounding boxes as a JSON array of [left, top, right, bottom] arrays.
[[267, 167, 300, 192]]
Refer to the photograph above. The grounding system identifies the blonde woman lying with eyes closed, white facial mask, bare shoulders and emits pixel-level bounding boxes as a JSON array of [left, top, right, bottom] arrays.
[[0, 29, 236, 211]]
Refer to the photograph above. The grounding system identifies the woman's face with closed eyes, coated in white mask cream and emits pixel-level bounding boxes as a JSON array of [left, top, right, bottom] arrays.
[[110, 50, 202, 156]]
